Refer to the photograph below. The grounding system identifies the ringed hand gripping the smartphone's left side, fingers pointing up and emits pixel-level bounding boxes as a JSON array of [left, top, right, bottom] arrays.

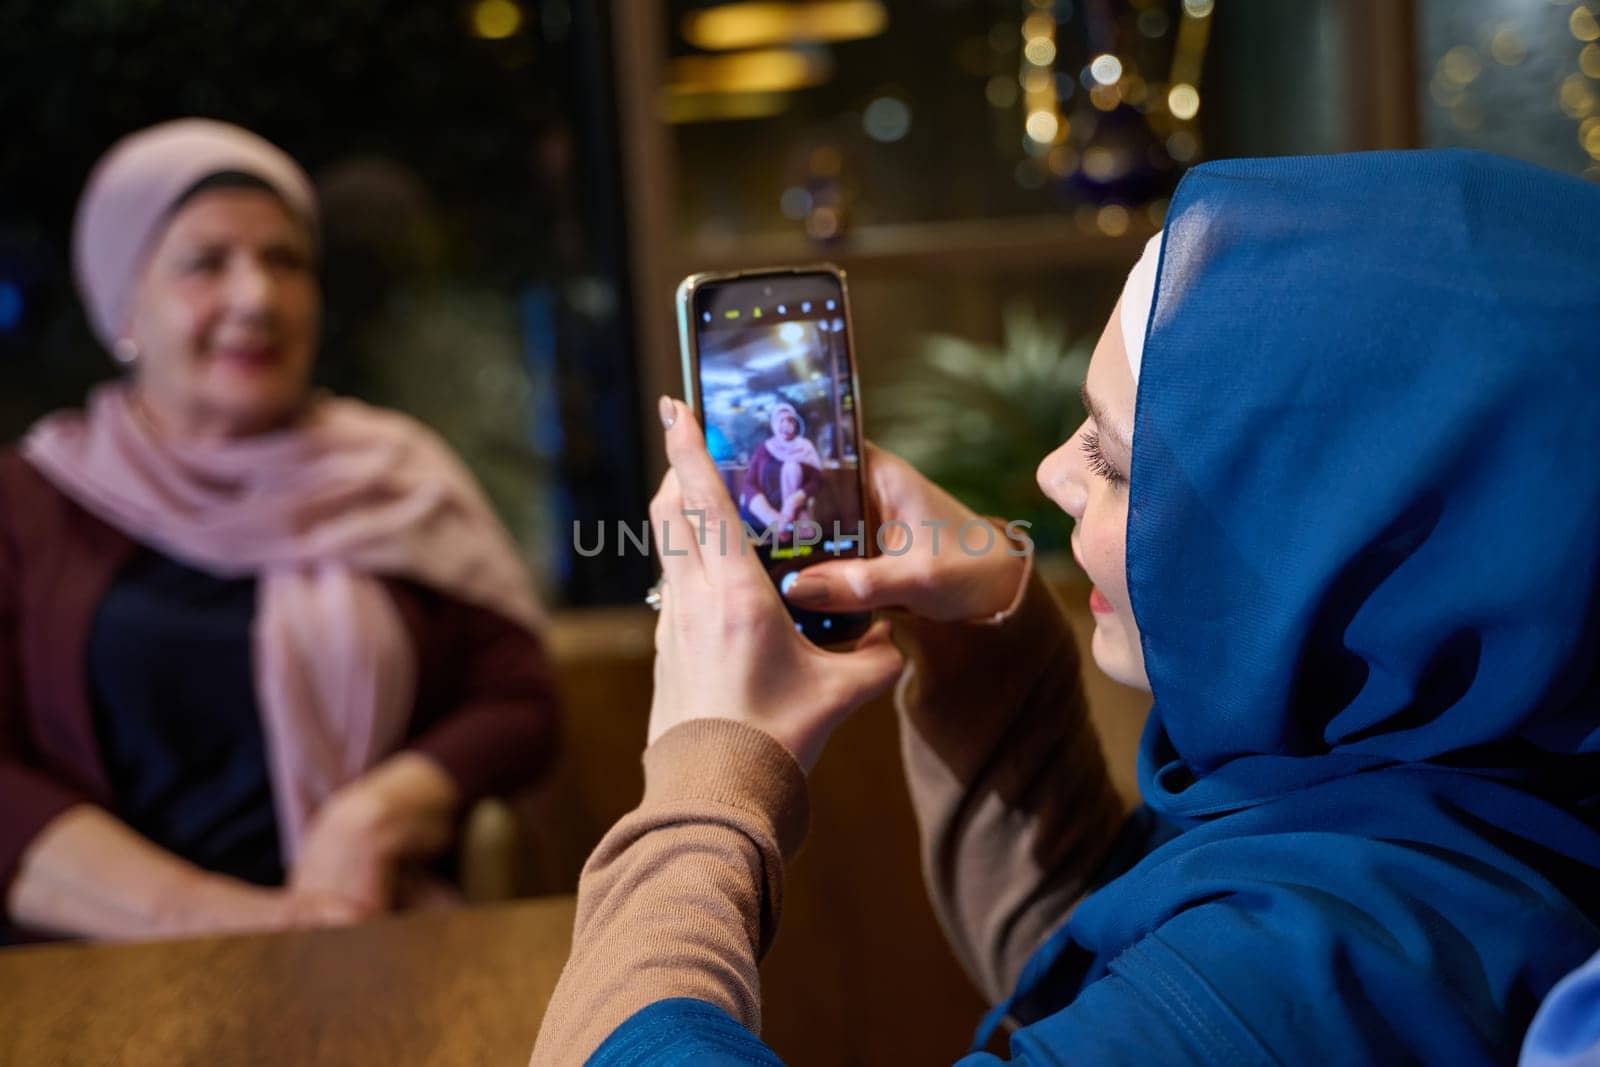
[[650, 397, 901, 769]]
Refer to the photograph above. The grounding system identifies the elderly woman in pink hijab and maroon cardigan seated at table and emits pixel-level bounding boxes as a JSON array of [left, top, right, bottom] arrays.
[[0, 120, 557, 937]]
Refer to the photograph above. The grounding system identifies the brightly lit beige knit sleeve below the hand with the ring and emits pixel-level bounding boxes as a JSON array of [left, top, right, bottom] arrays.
[[533, 718, 808, 1064]]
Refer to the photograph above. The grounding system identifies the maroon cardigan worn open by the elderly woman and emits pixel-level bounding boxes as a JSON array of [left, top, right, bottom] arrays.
[[0, 448, 560, 921]]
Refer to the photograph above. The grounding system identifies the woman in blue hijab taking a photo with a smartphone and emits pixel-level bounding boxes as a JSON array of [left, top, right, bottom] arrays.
[[534, 152, 1600, 1067]]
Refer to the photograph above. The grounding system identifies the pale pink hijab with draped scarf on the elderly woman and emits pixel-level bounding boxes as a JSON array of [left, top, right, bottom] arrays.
[[22, 120, 542, 862]]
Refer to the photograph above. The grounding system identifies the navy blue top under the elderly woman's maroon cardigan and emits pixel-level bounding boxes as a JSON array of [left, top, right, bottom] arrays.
[[88, 550, 283, 885]]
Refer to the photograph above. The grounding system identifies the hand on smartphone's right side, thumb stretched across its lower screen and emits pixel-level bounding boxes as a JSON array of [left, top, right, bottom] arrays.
[[787, 445, 1030, 622]]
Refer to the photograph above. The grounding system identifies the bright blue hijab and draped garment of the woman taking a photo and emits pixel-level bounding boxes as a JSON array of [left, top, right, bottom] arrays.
[[603, 150, 1600, 1067]]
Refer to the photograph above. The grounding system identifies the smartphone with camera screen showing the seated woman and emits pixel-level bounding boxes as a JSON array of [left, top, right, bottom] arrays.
[[678, 264, 874, 645]]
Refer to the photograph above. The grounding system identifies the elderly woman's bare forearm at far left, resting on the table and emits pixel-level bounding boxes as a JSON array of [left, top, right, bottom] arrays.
[[6, 805, 270, 941]]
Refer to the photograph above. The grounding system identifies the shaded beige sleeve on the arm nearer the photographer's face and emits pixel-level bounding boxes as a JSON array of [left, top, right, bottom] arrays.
[[894, 560, 1125, 1003]]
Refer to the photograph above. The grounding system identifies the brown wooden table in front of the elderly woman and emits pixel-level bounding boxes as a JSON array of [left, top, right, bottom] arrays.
[[0, 897, 573, 1067]]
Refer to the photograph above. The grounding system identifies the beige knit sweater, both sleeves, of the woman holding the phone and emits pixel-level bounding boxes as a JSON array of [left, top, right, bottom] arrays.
[[533, 571, 1123, 1064]]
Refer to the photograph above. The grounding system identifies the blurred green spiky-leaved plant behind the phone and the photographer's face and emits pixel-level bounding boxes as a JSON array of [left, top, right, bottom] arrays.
[[874, 304, 1093, 552]]
